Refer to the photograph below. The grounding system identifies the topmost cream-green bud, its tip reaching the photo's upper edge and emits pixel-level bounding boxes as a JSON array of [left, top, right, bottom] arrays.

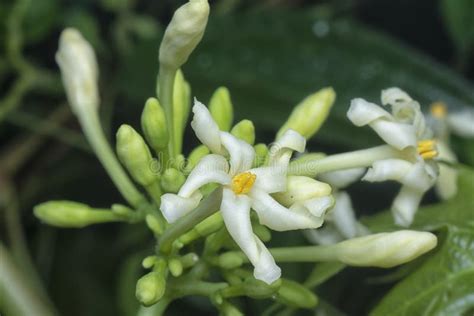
[[159, 0, 209, 69]]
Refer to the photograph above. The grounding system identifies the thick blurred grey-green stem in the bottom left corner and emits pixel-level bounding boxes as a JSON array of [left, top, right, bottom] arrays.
[[0, 242, 56, 316]]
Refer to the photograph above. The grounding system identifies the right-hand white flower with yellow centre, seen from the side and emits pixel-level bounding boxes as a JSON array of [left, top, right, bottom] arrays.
[[347, 88, 438, 226]]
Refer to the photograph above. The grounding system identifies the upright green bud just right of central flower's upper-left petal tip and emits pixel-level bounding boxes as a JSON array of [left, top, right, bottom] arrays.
[[209, 87, 234, 132]]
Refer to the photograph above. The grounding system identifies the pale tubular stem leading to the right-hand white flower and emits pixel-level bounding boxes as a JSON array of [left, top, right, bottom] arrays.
[[288, 145, 403, 177]]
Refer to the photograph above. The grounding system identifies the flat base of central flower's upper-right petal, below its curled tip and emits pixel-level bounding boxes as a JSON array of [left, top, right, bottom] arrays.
[[249, 165, 287, 193]]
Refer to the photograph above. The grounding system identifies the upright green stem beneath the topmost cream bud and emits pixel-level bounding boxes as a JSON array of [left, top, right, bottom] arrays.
[[156, 65, 177, 164]]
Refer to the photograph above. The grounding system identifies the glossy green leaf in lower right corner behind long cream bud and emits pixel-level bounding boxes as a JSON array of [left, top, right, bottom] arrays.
[[366, 168, 474, 316]]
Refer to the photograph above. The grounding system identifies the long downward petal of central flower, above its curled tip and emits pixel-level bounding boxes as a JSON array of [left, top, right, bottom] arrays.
[[221, 189, 259, 263]]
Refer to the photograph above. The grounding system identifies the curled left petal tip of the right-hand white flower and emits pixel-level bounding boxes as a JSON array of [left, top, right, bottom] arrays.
[[347, 98, 394, 127]]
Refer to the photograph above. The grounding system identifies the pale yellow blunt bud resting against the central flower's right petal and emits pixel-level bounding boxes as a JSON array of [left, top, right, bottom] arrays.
[[274, 176, 332, 206]]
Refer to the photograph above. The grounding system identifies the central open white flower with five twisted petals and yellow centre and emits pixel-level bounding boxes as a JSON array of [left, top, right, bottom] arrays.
[[160, 101, 332, 284]]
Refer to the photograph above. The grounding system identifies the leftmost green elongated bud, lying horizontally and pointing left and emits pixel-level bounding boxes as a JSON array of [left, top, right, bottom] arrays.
[[33, 201, 122, 228]]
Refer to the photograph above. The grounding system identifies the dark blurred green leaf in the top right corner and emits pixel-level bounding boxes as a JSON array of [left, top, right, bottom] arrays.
[[441, 0, 474, 51]]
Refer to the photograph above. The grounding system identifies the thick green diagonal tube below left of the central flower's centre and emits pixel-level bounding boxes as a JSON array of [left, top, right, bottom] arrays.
[[158, 187, 222, 253]]
